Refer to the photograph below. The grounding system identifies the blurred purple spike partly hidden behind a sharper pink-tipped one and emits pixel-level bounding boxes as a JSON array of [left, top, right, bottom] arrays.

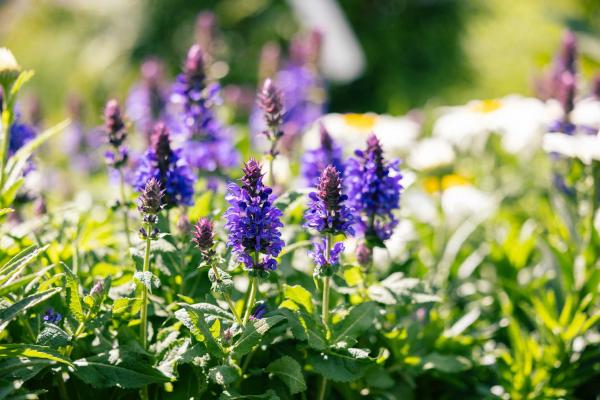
[[302, 123, 344, 186]]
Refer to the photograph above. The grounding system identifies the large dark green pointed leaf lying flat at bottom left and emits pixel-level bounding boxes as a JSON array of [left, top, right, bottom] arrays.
[[74, 351, 169, 389]]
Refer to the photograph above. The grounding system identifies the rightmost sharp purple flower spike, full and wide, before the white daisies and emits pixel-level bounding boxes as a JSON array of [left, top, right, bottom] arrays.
[[345, 135, 403, 247]]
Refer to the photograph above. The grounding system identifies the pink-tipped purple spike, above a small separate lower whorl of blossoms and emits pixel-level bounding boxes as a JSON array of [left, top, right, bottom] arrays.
[[304, 165, 354, 235]]
